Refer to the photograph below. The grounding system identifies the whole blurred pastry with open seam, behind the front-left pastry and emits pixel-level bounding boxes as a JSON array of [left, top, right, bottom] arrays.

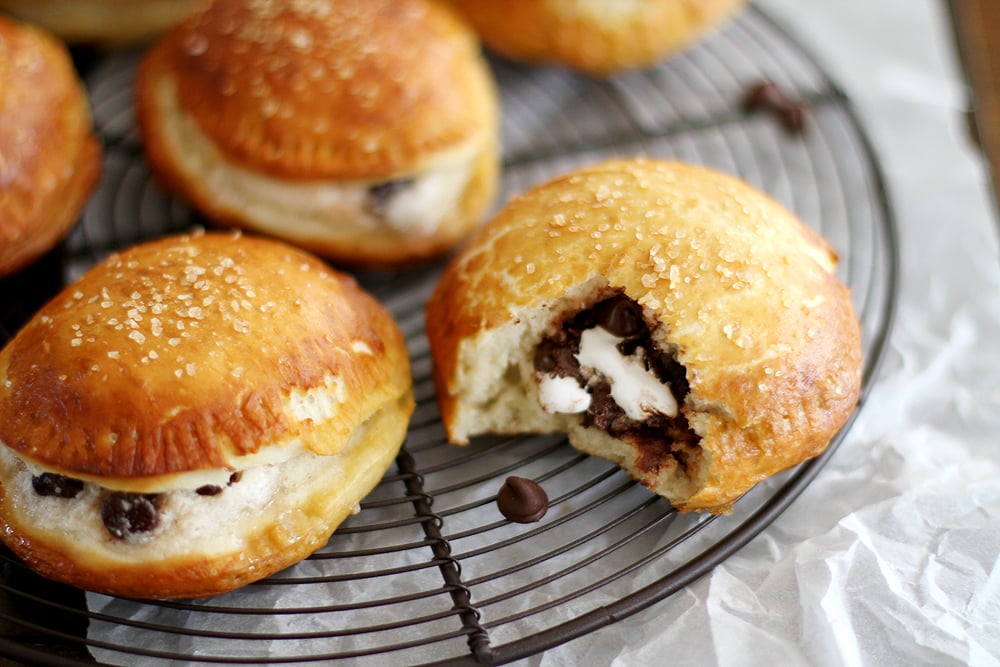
[[138, 0, 498, 265]]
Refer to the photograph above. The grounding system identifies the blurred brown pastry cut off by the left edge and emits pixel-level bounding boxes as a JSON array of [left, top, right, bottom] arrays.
[[0, 15, 101, 276]]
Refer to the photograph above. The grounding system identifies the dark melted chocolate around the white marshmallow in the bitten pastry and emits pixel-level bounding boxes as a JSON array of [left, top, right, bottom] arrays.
[[534, 294, 699, 472]]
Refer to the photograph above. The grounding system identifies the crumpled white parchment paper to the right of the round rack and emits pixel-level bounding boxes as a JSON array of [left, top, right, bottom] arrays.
[[89, 0, 1000, 667]]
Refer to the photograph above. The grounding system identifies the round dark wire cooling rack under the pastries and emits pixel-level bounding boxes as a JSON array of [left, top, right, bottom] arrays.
[[0, 7, 898, 665]]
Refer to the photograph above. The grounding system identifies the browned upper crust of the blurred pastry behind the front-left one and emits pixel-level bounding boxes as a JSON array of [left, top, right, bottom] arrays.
[[140, 0, 495, 179]]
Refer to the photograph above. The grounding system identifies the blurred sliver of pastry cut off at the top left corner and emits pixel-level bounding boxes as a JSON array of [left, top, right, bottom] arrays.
[[0, 0, 207, 48]]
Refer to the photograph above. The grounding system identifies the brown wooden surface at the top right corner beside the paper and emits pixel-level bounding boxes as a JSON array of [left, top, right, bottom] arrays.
[[948, 0, 1000, 209]]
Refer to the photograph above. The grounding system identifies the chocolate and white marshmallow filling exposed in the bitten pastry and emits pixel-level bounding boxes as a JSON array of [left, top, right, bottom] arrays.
[[534, 294, 701, 473]]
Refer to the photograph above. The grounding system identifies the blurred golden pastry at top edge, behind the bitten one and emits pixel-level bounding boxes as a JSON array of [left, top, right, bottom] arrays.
[[451, 0, 746, 76]]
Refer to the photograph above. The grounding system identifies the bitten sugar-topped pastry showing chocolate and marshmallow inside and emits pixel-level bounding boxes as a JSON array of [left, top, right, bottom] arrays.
[[427, 160, 861, 512]]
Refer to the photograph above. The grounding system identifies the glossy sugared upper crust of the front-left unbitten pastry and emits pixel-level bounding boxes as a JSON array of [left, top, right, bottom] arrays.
[[0, 234, 411, 488]]
